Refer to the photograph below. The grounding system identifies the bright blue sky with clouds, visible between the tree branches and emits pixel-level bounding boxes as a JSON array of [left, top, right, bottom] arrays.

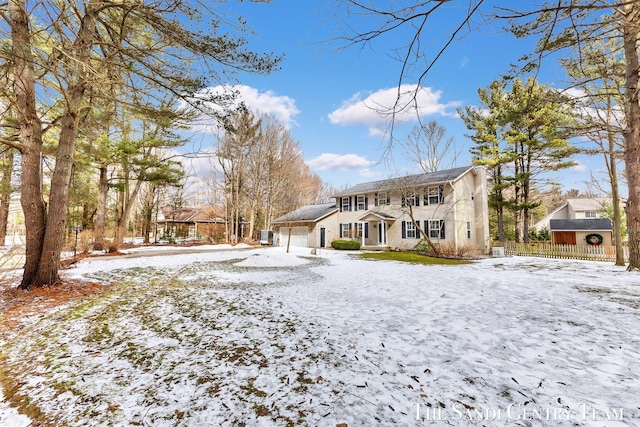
[[186, 0, 600, 194]]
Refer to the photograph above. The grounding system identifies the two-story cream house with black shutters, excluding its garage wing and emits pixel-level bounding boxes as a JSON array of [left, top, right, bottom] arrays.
[[334, 166, 489, 253]]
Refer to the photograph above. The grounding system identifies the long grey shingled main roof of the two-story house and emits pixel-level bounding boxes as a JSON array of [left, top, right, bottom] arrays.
[[332, 166, 475, 197]]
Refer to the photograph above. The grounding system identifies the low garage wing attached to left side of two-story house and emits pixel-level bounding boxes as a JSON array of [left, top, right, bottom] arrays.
[[271, 203, 338, 248]]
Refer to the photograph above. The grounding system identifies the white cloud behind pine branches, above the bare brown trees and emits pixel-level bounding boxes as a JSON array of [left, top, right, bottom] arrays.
[[186, 85, 300, 133]]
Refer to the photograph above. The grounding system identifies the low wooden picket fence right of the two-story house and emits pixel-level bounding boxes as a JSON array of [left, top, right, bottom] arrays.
[[495, 242, 629, 262]]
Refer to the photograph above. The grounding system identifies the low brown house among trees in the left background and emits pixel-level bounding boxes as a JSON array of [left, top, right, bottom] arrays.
[[156, 205, 226, 242]]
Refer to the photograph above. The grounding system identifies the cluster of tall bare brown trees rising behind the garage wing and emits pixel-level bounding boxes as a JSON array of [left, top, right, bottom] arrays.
[[215, 108, 327, 242]]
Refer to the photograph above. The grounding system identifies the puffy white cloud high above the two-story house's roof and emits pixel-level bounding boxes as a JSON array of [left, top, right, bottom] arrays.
[[328, 85, 460, 135]]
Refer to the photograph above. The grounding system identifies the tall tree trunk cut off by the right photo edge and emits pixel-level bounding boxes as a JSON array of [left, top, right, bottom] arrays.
[[622, 3, 640, 270]]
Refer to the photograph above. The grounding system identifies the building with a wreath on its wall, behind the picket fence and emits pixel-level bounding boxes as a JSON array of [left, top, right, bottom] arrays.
[[533, 198, 613, 246]]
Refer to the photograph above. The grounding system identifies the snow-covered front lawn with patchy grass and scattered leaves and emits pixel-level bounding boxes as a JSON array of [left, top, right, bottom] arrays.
[[0, 248, 640, 427]]
